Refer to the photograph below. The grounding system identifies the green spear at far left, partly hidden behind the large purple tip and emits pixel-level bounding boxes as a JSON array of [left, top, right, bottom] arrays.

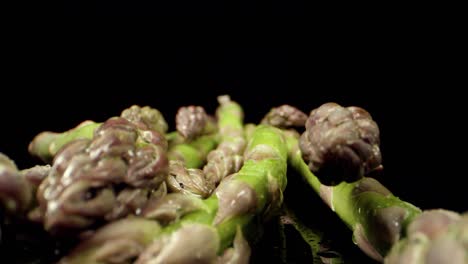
[[29, 105, 167, 163]]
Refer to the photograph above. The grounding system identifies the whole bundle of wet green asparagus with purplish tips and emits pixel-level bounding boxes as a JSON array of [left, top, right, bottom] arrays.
[[0, 95, 468, 264]]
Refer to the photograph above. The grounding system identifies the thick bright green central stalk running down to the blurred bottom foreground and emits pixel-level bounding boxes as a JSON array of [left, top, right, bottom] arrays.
[[61, 126, 287, 264]]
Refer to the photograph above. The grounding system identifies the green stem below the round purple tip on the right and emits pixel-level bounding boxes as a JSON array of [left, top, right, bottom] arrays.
[[285, 131, 421, 261]]
